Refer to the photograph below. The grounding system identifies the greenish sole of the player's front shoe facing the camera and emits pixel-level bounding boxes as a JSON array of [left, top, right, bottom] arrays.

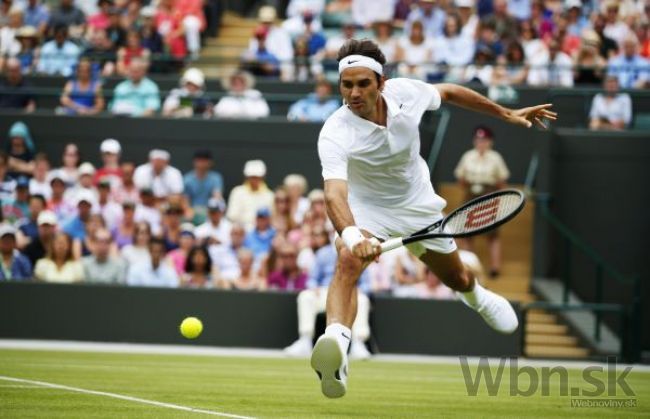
[[311, 336, 346, 399]]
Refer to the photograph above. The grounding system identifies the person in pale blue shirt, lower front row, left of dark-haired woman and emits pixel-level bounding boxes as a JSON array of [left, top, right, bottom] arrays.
[[126, 239, 178, 288]]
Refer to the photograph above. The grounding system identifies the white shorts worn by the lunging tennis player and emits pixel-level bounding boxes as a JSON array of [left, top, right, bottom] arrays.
[[350, 195, 457, 257]]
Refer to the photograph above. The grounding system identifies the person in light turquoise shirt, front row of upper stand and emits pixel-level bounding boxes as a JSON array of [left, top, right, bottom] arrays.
[[111, 58, 160, 116]]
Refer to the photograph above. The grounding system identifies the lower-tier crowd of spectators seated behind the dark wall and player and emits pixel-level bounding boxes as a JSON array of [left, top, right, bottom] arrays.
[[0, 122, 452, 298]]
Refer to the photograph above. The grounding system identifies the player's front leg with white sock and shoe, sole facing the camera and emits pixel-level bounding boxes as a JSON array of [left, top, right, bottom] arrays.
[[311, 239, 367, 398]]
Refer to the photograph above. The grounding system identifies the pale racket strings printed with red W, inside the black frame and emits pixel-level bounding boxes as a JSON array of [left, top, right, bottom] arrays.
[[444, 193, 522, 234]]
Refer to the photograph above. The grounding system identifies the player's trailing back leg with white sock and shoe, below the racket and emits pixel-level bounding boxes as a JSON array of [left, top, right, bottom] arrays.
[[419, 249, 519, 333]]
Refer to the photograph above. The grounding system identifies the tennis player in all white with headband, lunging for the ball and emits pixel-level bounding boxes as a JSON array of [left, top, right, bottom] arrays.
[[311, 39, 556, 397]]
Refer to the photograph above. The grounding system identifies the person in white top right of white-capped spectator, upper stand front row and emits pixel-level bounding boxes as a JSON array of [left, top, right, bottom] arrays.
[[214, 71, 270, 119]]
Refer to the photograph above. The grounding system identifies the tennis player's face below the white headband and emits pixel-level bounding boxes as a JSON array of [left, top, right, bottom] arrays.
[[339, 67, 384, 119]]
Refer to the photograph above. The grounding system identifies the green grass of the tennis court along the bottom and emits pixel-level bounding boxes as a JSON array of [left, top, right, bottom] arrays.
[[0, 350, 650, 418]]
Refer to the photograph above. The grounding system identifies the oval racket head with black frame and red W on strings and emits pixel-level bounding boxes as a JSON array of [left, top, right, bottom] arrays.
[[440, 189, 526, 237]]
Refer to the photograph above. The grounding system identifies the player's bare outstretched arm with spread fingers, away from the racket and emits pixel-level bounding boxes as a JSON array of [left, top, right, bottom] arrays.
[[435, 83, 557, 128]]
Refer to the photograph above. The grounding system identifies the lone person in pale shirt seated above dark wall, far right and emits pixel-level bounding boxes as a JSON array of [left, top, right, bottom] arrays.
[[589, 75, 632, 130]]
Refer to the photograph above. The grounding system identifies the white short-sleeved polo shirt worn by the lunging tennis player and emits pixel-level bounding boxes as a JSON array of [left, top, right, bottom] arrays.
[[318, 78, 446, 218]]
